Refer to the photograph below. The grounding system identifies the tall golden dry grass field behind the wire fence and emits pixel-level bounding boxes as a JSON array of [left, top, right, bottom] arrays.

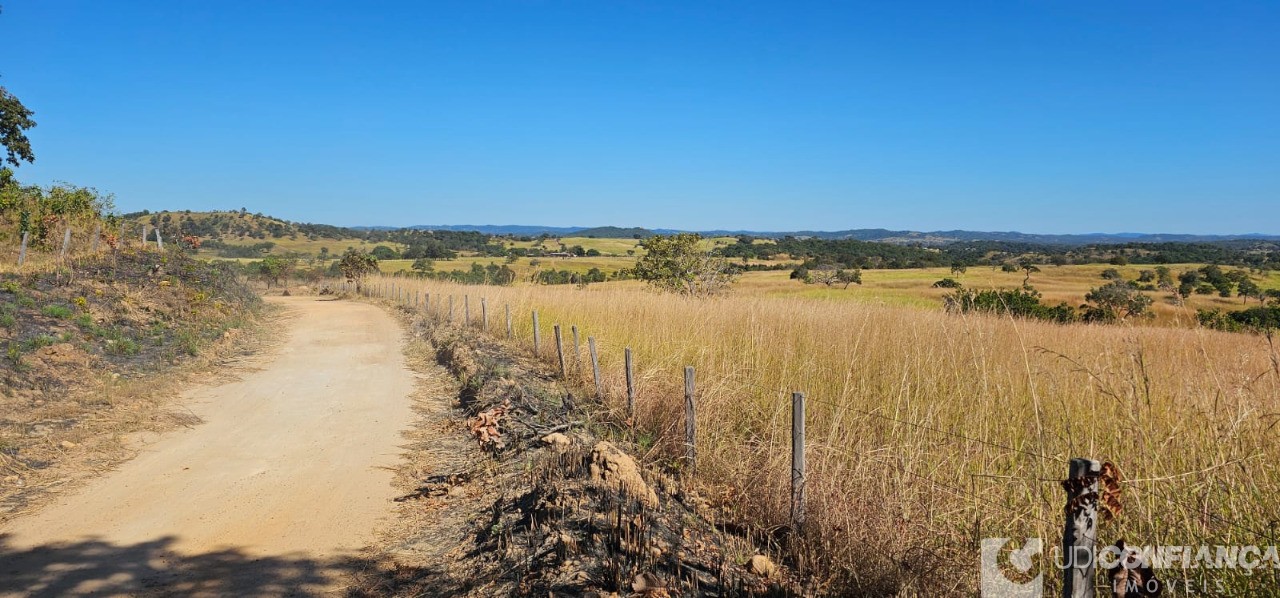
[[371, 278, 1280, 595]]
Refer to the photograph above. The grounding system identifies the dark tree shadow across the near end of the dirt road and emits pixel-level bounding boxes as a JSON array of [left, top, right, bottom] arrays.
[[0, 535, 371, 597]]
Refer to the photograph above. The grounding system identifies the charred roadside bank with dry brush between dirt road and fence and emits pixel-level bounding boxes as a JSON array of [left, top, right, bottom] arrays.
[[360, 314, 799, 597]]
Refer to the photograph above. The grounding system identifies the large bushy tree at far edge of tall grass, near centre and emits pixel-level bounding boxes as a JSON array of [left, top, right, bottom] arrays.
[[631, 233, 737, 297]]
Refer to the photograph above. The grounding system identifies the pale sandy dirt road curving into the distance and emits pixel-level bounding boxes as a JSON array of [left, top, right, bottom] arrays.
[[0, 297, 415, 595]]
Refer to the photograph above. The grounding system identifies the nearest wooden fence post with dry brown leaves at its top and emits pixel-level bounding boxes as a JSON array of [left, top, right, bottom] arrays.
[[1062, 457, 1102, 598]]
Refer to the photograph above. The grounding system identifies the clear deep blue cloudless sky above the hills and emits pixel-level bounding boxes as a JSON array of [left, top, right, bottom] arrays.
[[0, 0, 1280, 233]]
